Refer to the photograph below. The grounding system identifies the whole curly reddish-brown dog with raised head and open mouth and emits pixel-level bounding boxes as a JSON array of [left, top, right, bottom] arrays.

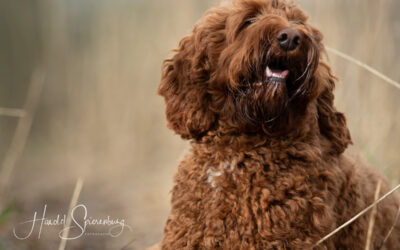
[[159, 0, 400, 250]]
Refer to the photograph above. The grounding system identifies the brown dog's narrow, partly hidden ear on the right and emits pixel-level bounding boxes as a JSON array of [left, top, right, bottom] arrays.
[[315, 62, 352, 154]]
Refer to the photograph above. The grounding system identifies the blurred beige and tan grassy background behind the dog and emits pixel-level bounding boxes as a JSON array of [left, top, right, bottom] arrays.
[[0, 0, 400, 250]]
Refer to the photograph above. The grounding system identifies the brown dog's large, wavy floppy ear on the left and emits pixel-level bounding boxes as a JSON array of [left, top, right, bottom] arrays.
[[158, 12, 225, 139]]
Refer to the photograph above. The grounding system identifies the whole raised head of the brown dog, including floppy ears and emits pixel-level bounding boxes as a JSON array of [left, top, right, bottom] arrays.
[[159, 0, 350, 152]]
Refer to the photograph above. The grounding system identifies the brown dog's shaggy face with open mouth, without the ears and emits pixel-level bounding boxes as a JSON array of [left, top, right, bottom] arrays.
[[216, 1, 322, 131]]
